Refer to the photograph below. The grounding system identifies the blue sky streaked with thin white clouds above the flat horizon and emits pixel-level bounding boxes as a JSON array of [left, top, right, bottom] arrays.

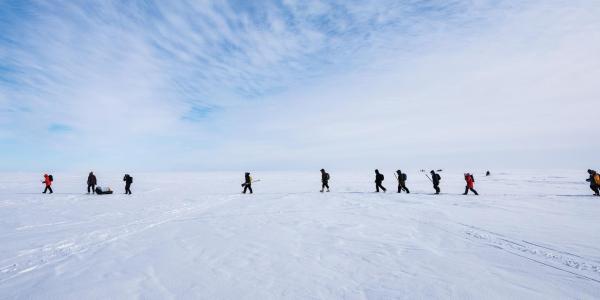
[[0, 0, 600, 171]]
